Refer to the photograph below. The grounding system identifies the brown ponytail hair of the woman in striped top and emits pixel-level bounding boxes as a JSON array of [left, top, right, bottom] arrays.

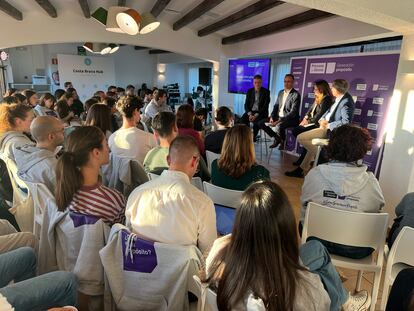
[[55, 126, 105, 211]]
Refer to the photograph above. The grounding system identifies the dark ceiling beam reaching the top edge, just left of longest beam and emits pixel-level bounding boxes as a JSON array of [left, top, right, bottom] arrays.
[[198, 0, 284, 37]]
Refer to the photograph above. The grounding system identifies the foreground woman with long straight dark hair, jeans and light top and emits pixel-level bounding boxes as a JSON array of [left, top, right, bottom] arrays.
[[205, 181, 370, 311]]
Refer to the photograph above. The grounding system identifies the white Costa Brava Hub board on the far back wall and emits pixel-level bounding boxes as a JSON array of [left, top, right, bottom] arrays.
[[58, 54, 115, 102]]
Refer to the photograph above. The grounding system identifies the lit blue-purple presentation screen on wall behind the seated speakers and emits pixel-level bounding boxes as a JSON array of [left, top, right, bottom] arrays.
[[228, 58, 270, 94]]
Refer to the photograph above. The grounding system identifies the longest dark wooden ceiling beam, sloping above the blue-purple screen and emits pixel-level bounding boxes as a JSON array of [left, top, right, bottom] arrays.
[[221, 10, 335, 45]]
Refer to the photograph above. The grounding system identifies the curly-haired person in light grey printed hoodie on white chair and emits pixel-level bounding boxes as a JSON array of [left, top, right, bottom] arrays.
[[300, 124, 385, 259]]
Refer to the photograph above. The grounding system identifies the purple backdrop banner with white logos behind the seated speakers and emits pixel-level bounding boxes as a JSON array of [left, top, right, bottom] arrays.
[[291, 53, 399, 176]]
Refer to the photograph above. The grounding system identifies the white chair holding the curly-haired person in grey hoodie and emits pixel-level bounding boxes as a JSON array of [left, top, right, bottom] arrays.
[[302, 202, 388, 310]]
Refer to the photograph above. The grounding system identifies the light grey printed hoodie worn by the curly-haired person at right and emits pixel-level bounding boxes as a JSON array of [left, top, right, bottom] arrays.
[[300, 162, 385, 223]]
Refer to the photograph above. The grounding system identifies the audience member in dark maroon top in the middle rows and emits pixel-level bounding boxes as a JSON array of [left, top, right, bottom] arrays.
[[177, 105, 205, 157]]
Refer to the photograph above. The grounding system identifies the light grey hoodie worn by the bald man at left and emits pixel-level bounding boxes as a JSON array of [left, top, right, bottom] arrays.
[[14, 145, 57, 193]]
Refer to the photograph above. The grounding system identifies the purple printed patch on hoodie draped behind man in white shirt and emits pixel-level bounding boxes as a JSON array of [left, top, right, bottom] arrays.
[[121, 230, 158, 273]]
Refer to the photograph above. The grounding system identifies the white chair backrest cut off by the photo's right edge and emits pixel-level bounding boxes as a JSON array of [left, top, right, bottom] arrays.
[[387, 226, 414, 268]]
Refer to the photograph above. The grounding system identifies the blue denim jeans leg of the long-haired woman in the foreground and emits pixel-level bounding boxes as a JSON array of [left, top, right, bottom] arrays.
[[299, 240, 349, 311]]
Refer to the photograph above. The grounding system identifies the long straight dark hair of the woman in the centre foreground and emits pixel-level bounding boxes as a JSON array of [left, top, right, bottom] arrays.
[[207, 181, 305, 311]]
